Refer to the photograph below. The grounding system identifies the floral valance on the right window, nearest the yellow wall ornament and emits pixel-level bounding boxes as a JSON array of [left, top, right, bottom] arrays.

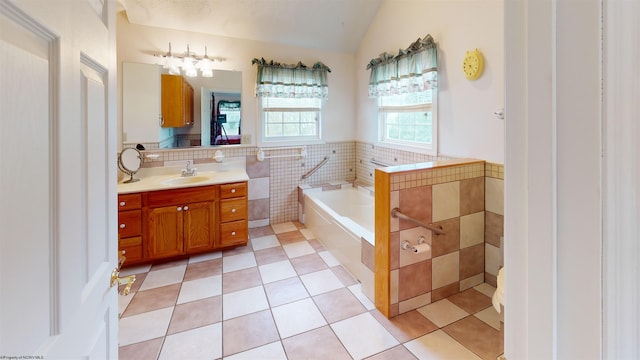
[[367, 35, 438, 98]]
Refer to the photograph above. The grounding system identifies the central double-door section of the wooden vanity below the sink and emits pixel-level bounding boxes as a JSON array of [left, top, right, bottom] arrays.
[[143, 185, 217, 260]]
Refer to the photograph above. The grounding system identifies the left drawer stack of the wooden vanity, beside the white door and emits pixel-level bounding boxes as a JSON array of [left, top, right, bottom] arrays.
[[118, 194, 143, 265]]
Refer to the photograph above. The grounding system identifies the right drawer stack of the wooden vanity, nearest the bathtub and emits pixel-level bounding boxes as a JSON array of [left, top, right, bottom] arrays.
[[217, 182, 249, 247]]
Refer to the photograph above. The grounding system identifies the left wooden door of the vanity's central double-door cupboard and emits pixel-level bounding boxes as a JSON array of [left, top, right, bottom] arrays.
[[147, 205, 184, 259]]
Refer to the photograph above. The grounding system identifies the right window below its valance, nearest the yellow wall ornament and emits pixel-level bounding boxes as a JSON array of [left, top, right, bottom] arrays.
[[378, 89, 437, 154]]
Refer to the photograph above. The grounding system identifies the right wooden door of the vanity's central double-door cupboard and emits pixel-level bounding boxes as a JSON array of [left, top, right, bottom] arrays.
[[183, 201, 216, 253]]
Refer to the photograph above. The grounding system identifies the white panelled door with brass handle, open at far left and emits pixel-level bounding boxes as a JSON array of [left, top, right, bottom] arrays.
[[0, 0, 118, 359]]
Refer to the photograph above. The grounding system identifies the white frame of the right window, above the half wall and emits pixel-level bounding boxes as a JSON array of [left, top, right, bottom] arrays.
[[377, 89, 439, 156]]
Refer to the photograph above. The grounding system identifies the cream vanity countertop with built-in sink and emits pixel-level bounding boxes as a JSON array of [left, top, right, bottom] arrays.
[[117, 161, 249, 194]]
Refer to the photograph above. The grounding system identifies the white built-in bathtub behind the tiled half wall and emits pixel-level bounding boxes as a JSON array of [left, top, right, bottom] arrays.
[[304, 187, 375, 301]]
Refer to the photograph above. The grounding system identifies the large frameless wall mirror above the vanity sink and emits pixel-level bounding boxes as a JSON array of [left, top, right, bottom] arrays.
[[122, 62, 242, 149]]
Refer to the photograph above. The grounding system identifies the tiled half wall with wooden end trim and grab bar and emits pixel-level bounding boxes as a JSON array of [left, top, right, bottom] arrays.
[[375, 160, 490, 317]]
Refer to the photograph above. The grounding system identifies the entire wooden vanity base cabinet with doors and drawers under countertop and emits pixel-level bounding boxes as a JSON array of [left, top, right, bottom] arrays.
[[118, 182, 249, 266]]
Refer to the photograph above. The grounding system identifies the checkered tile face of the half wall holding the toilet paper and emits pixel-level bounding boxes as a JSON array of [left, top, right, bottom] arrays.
[[390, 162, 492, 316]]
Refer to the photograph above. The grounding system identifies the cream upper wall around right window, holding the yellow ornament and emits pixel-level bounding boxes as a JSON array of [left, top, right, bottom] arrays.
[[355, 0, 504, 163]]
